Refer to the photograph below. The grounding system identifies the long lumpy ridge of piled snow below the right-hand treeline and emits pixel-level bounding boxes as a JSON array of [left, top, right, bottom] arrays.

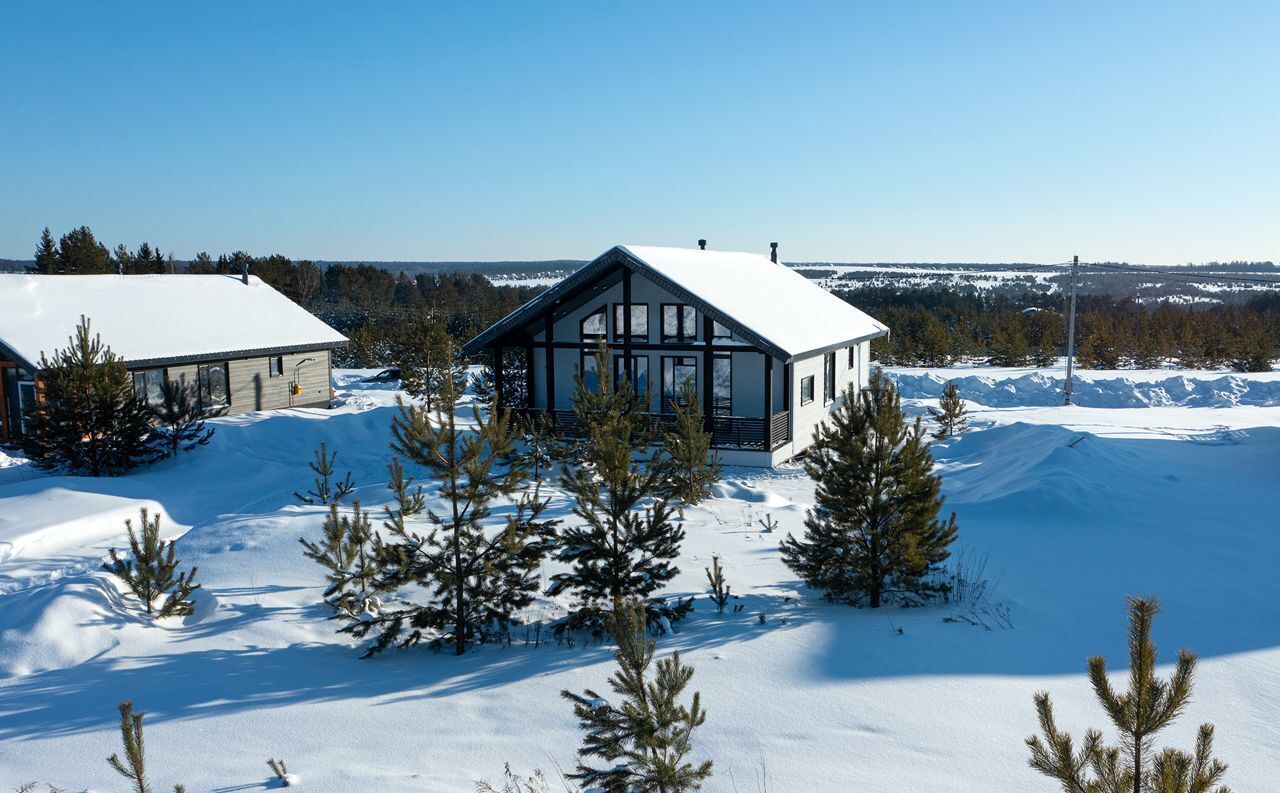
[[888, 370, 1280, 408]]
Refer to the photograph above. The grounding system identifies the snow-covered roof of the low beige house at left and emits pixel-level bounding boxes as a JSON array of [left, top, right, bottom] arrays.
[[0, 275, 347, 366]]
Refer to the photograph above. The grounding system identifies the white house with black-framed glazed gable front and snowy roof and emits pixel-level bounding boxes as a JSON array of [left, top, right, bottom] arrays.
[[463, 244, 888, 466]]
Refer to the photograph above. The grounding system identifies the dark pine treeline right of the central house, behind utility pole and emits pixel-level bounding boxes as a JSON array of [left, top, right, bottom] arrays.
[[836, 287, 1280, 371]]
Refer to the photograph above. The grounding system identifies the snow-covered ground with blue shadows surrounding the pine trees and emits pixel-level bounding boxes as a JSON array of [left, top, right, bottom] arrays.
[[0, 368, 1280, 793]]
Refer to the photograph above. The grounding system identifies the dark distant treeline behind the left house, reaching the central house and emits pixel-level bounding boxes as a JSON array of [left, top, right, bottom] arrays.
[[28, 226, 541, 366]]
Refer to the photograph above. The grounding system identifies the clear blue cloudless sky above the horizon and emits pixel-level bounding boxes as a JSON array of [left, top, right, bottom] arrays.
[[0, 0, 1280, 262]]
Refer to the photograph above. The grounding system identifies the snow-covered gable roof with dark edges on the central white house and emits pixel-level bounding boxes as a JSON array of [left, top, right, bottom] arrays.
[[466, 246, 888, 358]]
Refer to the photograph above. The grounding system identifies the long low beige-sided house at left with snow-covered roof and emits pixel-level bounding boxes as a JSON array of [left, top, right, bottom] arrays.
[[0, 274, 347, 441]]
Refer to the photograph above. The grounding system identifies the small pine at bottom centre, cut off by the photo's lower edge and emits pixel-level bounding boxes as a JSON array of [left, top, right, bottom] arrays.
[[561, 604, 712, 793]]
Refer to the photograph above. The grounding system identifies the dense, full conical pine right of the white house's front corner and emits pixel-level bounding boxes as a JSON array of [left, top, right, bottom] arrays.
[[782, 368, 957, 609]]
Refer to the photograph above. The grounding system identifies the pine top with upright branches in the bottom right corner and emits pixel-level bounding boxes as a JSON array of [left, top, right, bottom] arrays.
[[1027, 597, 1229, 793]]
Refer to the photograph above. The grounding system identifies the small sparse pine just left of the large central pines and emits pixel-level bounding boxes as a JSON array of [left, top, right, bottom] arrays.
[[298, 501, 381, 619]]
